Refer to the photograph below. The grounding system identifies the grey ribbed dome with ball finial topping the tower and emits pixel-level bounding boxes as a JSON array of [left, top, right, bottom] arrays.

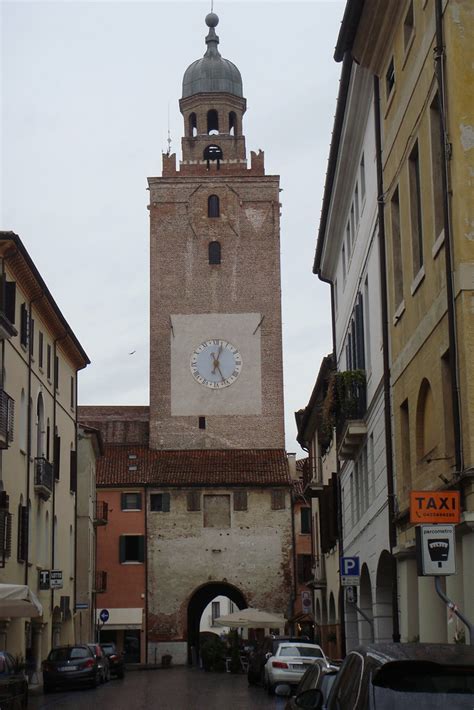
[[182, 12, 243, 99]]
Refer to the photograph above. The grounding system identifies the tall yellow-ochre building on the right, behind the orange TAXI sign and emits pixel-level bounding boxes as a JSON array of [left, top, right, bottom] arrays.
[[335, 0, 474, 641]]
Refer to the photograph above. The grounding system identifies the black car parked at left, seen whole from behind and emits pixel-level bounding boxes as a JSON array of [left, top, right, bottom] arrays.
[[43, 644, 101, 693]]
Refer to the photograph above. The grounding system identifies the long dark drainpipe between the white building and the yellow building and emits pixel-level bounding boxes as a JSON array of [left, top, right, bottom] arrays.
[[374, 76, 400, 642]]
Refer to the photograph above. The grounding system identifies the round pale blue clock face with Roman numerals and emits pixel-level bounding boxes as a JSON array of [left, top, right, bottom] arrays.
[[190, 339, 242, 389]]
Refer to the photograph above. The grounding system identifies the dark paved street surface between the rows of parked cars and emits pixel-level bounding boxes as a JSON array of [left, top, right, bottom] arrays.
[[28, 667, 285, 710]]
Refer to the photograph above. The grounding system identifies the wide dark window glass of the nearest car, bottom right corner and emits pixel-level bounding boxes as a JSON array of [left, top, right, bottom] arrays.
[[371, 663, 474, 710]]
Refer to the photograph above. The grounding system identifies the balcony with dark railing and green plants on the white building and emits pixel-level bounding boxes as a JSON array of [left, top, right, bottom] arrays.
[[336, 370, 367, 460]]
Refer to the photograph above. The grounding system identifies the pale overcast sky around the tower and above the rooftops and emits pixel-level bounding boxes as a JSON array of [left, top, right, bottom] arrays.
[[0, 0, 345, 455]]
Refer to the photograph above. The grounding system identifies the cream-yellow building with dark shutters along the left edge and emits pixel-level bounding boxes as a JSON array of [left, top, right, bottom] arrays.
[[0, 232, 89, 670]]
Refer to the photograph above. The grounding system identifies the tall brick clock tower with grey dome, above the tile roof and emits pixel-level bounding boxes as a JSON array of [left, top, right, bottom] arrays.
[[148, 13, 284, 450]]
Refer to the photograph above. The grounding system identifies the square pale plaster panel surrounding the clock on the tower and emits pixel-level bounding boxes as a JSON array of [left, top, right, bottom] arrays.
[[170, 313, 262, 416]]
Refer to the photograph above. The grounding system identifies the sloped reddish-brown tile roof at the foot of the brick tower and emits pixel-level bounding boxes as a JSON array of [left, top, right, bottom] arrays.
[[97, 444, 290, 486]]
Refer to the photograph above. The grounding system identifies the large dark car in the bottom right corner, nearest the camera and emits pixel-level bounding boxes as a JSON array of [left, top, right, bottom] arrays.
[[304, 643, 474, 710]]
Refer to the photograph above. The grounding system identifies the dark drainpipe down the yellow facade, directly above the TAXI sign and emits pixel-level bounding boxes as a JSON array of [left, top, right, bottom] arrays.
[[435, 0, 464, 476]]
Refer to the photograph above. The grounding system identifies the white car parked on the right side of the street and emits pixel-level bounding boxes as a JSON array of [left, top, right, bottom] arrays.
[[264, 643, 329, 694]]
